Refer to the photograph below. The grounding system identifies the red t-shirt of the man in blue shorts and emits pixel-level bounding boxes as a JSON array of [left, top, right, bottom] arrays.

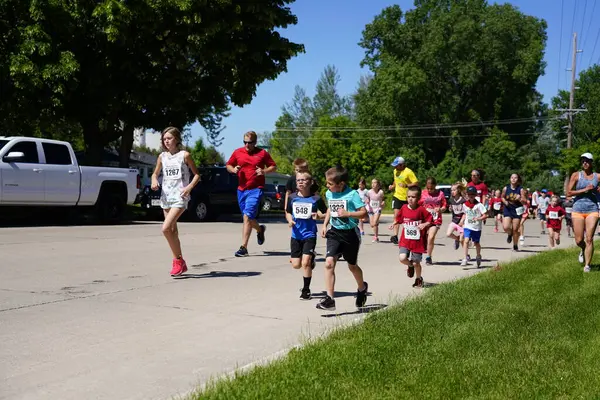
[[227, 147, 275, 190]]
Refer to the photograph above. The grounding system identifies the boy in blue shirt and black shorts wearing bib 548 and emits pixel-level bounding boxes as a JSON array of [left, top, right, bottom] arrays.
[[285, 172, 327, 300]]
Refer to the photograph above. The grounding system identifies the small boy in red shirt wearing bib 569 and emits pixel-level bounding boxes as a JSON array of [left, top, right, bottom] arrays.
[[390, 187, 433, 287]]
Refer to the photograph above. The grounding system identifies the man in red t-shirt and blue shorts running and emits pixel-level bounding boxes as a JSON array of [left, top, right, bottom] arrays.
[[227, 131, 277, 257]]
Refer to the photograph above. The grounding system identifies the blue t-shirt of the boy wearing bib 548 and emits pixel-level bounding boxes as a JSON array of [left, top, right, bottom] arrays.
[[286, 193, 327, 240]]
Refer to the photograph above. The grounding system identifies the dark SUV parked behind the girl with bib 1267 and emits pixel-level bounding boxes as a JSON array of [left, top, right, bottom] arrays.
[[141, 167, 239, 221]]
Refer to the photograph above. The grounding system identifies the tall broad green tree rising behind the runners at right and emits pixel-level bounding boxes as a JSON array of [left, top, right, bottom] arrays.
[[355, 0, 546, 164]]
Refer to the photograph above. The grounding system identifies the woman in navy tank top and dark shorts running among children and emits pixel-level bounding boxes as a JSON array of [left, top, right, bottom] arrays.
[[502, 174, 525, 251]]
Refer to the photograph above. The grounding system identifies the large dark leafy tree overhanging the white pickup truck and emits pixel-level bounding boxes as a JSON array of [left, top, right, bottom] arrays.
[[0, 0, 304, 166]]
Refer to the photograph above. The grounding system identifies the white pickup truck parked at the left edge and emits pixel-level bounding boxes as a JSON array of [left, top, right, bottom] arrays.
[[0, 137, 140, 223]]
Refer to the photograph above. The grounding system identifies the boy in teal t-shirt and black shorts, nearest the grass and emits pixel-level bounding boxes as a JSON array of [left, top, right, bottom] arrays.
[[317, 167, 369, 311]]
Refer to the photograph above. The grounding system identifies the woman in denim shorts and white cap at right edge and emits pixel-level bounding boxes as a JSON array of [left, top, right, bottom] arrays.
[[567, 153, 598, 272]]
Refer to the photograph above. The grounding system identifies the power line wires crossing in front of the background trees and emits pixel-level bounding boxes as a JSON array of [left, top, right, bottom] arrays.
[[276, 117, 560, 132]]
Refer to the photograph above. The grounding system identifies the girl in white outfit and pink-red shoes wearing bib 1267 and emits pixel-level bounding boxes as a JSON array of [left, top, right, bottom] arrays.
[[152, 127, 200, 276]]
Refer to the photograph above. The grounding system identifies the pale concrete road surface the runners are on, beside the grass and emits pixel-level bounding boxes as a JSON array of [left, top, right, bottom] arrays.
[[0, 215, 573, 400]]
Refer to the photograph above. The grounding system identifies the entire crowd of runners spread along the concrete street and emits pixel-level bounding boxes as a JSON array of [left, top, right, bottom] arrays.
[[152, 127, 599, 310]]
